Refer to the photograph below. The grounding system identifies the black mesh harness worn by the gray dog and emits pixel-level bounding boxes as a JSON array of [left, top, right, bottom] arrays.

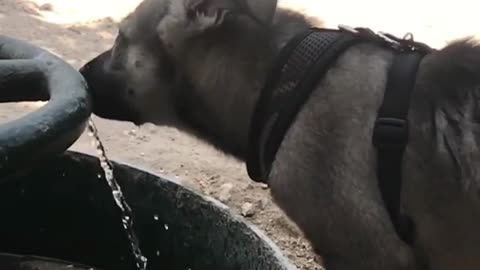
[[247, 27, 433, 244]]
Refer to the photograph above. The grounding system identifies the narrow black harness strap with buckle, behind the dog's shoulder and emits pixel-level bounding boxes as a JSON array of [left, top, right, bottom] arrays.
[[373, 51, 424, 244]]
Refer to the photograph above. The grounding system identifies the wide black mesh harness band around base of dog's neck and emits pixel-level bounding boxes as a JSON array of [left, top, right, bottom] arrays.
[[247, 28, 364, 182]]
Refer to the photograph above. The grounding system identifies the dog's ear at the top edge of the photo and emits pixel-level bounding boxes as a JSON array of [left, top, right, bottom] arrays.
[[157, 0, 277, 53]]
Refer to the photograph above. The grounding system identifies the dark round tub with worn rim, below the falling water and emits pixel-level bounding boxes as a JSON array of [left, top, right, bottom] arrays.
[[0, 152, 295, 270]]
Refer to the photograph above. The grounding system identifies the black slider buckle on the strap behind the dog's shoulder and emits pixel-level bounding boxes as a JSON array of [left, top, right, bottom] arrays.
[[373, 117, 408, 149]]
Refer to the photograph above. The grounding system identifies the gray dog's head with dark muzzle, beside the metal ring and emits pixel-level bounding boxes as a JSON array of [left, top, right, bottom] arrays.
[[80, 0, 277, 125]]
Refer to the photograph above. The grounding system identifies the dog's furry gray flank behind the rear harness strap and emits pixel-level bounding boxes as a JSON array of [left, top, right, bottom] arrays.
[[404, 40, 480, 270]]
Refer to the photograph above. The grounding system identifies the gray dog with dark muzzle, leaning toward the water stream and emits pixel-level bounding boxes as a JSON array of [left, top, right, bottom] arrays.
[[81, 0, 480, 270]]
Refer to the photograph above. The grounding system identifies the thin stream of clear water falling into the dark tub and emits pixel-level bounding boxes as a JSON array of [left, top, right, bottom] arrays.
[[88, 118, 147, 270]]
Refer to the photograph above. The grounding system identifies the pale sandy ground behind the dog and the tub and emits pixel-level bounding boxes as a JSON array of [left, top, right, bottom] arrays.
[[0, 0, 480, 270]]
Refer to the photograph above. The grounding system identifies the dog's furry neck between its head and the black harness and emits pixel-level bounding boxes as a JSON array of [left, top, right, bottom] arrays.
[[176, 9, 318, 160]]
